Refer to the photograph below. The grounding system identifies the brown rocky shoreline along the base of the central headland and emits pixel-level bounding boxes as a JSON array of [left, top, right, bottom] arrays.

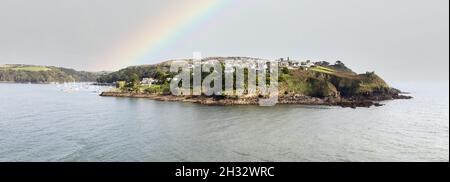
[[100, 92, 412, 108]]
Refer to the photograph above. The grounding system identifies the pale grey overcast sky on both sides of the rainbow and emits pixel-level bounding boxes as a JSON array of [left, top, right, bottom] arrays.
[[0, 0, 449, 82]]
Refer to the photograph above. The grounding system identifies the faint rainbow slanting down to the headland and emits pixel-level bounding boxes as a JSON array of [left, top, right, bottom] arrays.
[[103, 0, 231, 67]]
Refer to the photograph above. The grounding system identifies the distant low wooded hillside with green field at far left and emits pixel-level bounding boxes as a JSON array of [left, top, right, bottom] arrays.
[[0, 64, 100, 83]]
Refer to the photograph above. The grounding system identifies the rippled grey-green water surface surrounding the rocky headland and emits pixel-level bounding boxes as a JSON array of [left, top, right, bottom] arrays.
[[0, 84, 449, 161]]
